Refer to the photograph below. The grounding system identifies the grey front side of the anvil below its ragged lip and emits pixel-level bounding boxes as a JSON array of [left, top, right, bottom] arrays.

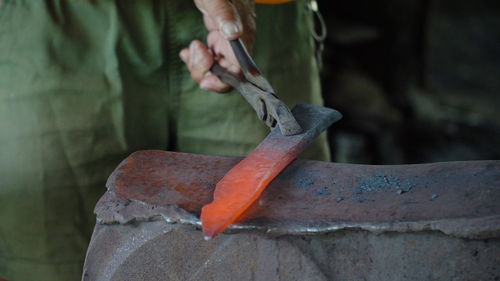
[[83, 215, 500, 281]]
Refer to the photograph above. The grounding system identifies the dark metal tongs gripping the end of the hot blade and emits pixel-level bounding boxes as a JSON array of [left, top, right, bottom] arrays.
[[210, 39, 302, 136]]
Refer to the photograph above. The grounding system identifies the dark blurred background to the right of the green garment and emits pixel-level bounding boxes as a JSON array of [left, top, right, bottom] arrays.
[[316, 0, 500, 164]]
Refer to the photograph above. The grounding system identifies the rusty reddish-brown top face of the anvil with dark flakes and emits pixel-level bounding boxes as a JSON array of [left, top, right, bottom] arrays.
[[103, 151, 500, 238]]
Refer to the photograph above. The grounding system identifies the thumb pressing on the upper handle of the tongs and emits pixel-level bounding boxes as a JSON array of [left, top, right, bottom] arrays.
[[195, 0, 243, 40]]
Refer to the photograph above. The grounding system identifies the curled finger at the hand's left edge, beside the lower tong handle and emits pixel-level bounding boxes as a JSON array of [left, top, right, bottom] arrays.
[[186, 40, 214, 83]]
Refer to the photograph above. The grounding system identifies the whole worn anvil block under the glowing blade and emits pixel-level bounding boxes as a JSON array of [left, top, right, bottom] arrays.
[[83, 151, 500, 281]]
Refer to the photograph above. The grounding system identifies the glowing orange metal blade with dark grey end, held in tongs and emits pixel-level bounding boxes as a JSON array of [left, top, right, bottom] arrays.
[[201, 104, 341, 239]]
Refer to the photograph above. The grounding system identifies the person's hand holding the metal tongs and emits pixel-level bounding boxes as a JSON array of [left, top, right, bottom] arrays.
[[179, 0, 255, 93]]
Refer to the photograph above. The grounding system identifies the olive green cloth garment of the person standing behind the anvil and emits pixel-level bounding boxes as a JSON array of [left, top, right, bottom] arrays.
[[0, 0, 328, 281]]
